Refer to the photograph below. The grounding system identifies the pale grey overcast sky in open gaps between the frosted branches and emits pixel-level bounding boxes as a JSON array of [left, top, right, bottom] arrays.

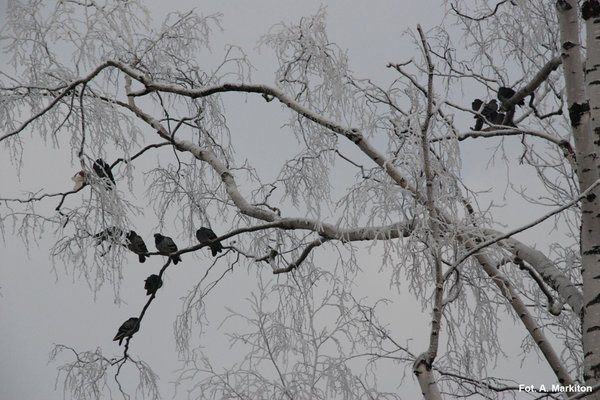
[[0, 0, 568, 400]]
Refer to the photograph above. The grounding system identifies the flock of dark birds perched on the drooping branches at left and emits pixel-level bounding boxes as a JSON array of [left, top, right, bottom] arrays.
[[82, 158, 223, 346]]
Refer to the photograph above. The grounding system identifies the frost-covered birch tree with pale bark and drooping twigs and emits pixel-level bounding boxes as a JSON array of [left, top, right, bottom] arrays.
[[0, 0, 600, 400]]
